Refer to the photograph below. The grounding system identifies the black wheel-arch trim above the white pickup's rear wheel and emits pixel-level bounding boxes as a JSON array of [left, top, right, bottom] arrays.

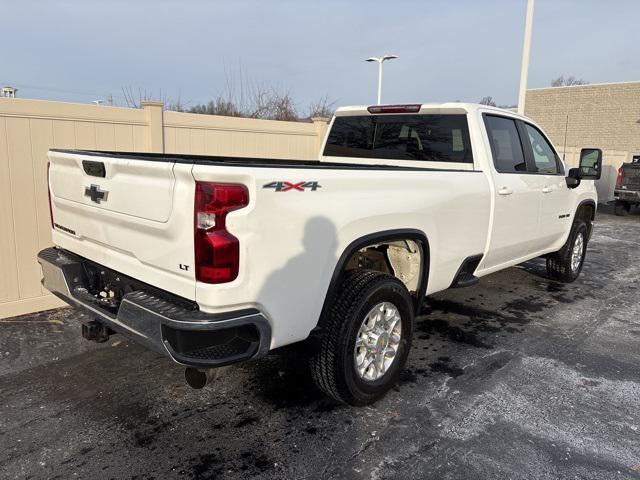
[[318, 228, 431, 324]]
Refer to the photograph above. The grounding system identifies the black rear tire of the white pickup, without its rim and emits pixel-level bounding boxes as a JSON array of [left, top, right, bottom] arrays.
[[310, 269, 414, 406]]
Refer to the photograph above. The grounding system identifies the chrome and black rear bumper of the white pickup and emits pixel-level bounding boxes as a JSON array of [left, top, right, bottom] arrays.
[[38, 248, 271, 368]]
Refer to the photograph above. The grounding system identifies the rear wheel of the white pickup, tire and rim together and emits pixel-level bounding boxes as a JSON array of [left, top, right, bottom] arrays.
[[310, 269, 414, 405]]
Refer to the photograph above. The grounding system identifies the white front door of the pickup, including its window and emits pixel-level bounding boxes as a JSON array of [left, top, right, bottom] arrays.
[[518, 120, 573, 252]]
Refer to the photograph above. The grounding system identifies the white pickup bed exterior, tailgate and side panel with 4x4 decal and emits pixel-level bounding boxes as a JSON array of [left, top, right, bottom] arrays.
[[49, 149, 491, 348]]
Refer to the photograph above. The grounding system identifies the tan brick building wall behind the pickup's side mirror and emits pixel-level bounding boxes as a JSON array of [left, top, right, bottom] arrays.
[[525, 82, 640, 202]]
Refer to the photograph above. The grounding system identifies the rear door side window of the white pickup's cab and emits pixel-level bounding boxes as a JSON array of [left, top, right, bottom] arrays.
[[484, 115, 527, 173]]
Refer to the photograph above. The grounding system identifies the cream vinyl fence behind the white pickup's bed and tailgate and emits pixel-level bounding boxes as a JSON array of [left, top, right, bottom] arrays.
[[0, 98, 326, 318]]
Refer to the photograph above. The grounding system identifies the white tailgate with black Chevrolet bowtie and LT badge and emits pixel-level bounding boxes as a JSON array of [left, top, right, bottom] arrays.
[[49, 150, 195, 299]]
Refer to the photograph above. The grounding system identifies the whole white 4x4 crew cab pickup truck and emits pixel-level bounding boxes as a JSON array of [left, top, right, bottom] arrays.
[[38, 103, 602, 405]]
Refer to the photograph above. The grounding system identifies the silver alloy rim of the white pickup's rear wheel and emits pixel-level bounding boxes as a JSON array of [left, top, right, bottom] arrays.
[[353, 302, 402, 382]]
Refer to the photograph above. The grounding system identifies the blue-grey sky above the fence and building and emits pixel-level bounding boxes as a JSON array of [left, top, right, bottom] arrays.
[[0, 0, 640, 110]]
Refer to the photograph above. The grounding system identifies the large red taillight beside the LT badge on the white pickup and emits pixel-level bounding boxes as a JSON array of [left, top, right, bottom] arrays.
[[194, 182, 249, 283]]
